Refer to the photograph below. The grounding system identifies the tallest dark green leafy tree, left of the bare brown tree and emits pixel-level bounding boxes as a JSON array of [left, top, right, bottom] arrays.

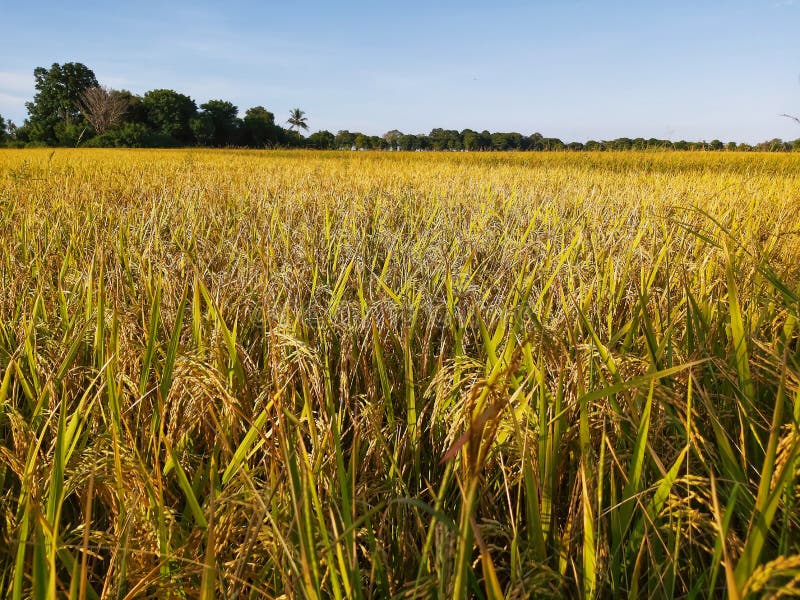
[[25, 62, 98, 145]]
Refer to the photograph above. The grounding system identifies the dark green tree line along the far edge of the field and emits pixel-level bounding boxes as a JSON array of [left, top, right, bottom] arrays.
[[0, 62, 800, 152]]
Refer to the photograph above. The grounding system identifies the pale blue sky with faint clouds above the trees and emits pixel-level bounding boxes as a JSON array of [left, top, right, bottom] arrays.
[[0, 0, 800, 142]]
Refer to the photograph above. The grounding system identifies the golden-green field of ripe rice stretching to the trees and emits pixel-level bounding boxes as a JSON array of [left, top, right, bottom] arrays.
[[0, 150, 800, 599]]
